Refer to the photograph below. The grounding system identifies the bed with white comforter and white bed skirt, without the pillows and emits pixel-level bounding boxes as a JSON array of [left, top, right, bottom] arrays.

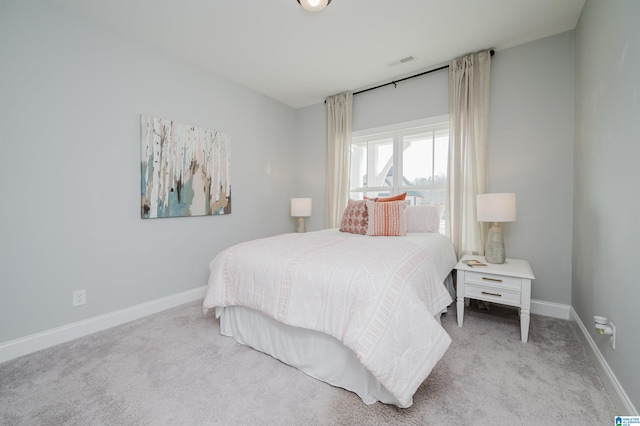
[[203, 218, 456, 408]]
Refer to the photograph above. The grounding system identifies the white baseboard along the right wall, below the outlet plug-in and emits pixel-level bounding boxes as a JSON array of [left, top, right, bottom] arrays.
[[571, 308, 638, 416]]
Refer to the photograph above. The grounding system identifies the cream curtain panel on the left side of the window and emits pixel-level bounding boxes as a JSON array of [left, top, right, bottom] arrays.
[[324, 92, 353, 228]]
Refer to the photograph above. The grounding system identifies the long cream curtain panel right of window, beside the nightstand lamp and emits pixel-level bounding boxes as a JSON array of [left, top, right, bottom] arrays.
[[446, 51, 491, 258]]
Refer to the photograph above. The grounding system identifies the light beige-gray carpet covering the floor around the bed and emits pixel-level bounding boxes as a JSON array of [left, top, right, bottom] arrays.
[[0, 303, 616, 425]]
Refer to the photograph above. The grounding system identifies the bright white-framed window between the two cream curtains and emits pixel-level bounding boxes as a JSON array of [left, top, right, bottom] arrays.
[[349, 116, 449, 229]]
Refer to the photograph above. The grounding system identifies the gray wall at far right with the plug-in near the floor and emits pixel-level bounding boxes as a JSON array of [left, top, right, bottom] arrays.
[[571, 0, 640, 414]]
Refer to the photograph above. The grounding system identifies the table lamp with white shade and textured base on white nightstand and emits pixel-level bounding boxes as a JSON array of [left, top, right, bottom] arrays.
[[476, 193, 516, 263]]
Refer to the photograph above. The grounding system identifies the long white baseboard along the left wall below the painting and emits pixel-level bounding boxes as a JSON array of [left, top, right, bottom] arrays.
[[0, 286, 206, 362]]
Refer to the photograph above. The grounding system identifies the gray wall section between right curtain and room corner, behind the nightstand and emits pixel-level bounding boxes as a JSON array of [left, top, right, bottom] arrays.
[[487, 31, 574, 305]]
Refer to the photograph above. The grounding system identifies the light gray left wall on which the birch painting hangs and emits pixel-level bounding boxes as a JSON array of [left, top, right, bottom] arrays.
[[0, 0, 296, 342]]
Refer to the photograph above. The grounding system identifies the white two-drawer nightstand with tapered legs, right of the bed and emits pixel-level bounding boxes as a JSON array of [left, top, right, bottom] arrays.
[[456, 256, 535, 342]]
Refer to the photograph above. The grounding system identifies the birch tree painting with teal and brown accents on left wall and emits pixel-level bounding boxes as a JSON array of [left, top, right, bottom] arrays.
[[140, 115, 231, 219]]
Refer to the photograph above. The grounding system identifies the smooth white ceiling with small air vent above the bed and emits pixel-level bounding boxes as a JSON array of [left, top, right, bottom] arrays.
[[53, 0, 585, 108]]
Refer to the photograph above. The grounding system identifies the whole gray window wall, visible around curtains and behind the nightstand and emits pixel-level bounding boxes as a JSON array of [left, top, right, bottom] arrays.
[[296, 31, 574, 305]]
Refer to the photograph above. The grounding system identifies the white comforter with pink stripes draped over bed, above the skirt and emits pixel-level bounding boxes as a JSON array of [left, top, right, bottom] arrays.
[[203, 230, 455, 407]]
